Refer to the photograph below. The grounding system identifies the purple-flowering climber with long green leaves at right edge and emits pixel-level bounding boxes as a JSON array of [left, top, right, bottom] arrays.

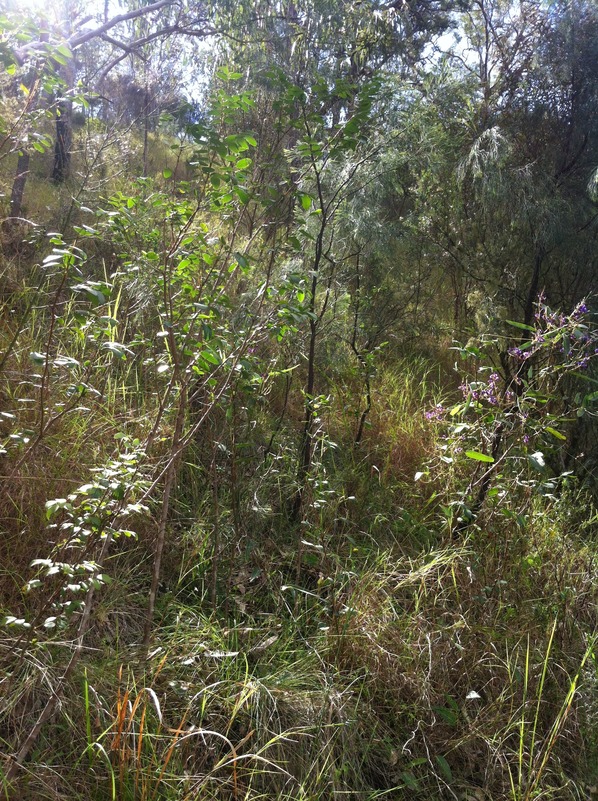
[[425, 296, 598, 531]]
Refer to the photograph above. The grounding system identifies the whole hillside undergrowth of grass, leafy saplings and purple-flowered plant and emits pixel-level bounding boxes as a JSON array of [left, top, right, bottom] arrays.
[[0, 37, 598, 801]]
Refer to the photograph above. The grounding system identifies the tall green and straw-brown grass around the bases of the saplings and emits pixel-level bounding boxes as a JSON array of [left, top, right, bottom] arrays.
[[0, 228, 598, 801]]
